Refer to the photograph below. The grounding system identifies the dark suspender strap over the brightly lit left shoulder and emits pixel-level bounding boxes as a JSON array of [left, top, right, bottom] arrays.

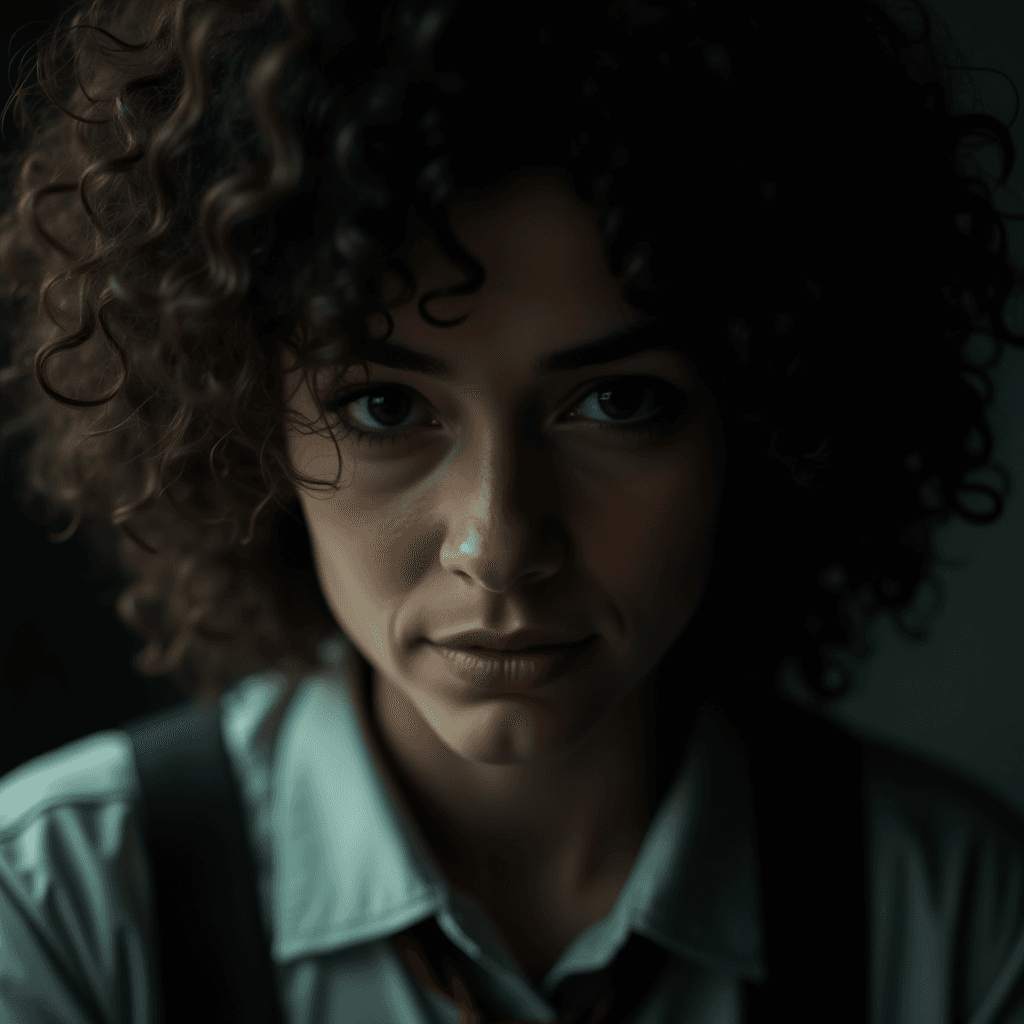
[[125, 701, 283, 1024]]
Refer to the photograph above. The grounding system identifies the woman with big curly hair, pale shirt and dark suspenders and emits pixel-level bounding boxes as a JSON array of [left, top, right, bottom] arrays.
[[0, 0, 1024, 1024]]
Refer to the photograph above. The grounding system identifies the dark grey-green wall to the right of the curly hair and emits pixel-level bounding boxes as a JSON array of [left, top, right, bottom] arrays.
[[835, 0, 1024, 813]]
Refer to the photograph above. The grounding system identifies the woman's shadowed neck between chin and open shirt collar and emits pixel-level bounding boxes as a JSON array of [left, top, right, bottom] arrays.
[[352, 651, 688, 893]]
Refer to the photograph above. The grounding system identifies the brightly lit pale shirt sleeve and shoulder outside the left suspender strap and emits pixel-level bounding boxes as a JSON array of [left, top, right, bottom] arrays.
[[0, 732, 155, 1024]]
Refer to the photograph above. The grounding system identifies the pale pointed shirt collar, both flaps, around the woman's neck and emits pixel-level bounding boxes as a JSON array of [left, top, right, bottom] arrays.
[[225, 638, 765, 981]]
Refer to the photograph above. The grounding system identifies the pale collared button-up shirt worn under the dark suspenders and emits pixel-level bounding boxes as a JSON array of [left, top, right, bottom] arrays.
[[0, 643, 1024, 1024]]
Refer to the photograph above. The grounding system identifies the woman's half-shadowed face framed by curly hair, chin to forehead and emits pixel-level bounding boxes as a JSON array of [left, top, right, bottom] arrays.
[[284, 177, 724, 765]]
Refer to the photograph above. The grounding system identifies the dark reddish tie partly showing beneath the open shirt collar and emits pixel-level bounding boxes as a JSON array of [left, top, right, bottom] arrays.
[[392, 918, 670, 1024]]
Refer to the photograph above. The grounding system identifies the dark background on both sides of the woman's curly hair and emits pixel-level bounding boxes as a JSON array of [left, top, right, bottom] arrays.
[[0, 0, 1024, 813]]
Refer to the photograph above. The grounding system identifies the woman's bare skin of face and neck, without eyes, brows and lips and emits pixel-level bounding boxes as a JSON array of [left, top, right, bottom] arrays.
[[283, 176, 724, 979]]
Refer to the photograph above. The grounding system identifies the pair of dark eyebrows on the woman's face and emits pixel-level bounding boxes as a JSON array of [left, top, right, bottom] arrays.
[[359, 319, 676, 376]]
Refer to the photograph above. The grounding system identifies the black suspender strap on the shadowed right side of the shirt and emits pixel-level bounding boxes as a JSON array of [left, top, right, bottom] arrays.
[[742, 699, 867, 1024]]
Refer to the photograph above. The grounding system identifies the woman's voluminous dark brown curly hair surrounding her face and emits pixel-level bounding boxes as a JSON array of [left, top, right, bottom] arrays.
[[0, 0, 1022, 716]]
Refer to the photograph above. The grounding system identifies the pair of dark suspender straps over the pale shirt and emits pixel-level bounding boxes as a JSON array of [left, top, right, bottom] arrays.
[[125, 699, 867, 1024]]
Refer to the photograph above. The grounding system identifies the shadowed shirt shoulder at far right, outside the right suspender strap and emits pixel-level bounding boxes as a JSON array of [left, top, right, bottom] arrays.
[[863, 742, 1024, 1020]]
